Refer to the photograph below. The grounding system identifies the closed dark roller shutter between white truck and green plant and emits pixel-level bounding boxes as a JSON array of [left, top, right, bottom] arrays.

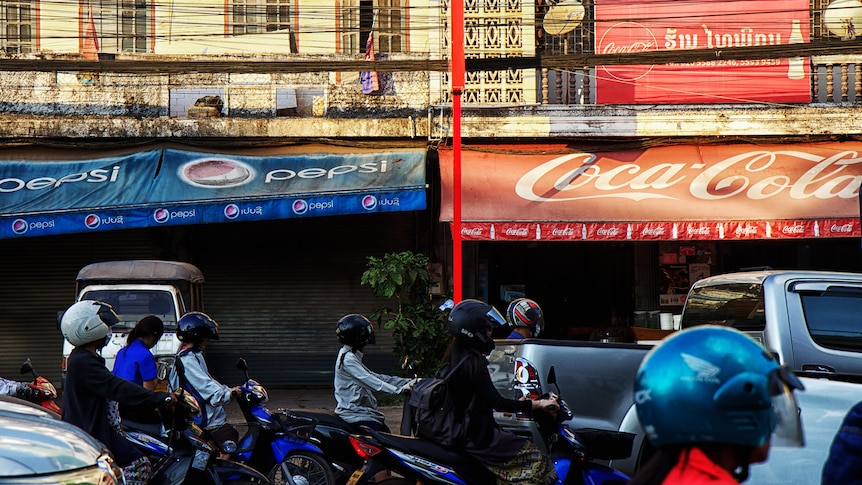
[[191, 213, 426, 387]]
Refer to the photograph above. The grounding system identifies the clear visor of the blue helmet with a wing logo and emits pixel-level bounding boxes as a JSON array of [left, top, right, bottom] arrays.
[[770, 367, 805, 448]]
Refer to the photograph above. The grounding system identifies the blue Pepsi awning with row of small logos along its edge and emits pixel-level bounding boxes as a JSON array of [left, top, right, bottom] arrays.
[[0, 148, 426, 238]]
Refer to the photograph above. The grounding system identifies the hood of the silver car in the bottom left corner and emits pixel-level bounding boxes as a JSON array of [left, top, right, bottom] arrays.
[[0, 397, 105, 477]]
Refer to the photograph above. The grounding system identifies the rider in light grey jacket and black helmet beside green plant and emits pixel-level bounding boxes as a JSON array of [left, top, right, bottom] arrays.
[[334, 313, 413, 432]]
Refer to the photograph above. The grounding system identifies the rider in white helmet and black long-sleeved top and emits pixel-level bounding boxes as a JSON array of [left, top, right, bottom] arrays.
[[60, 300, 177, 484]]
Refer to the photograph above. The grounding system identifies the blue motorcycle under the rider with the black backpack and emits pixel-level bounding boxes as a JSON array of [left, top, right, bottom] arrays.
[[347, 367, 634, 485]]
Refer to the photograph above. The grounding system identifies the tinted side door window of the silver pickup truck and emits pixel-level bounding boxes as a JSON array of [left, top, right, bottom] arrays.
[[799, 289, 862, 352]]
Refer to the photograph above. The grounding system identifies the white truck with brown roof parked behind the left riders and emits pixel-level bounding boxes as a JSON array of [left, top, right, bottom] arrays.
[[57, 260, 204, 388]]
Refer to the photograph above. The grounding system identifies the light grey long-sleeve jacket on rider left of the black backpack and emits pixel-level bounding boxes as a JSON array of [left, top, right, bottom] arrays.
[[335, 345, 411, 424]]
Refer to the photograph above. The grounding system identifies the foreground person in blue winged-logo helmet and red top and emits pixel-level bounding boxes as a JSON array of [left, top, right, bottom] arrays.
[[629, 325, 803, 485]]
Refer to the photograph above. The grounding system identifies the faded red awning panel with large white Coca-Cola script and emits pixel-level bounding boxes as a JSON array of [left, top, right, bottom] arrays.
[[439, 142, 862, 227]]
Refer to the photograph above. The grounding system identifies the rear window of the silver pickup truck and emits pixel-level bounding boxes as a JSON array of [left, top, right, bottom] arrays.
[[683, 283, 766, 331]]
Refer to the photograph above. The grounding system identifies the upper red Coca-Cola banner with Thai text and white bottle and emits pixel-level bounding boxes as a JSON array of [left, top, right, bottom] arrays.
[[595, 0, 811, 104]]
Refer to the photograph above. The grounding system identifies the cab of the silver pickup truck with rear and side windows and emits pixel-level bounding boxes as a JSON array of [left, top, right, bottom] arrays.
[[680, 270, 862, 374]]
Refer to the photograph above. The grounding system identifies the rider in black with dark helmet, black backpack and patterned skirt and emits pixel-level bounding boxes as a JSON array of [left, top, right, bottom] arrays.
[[444, 300, 557, 485]]
